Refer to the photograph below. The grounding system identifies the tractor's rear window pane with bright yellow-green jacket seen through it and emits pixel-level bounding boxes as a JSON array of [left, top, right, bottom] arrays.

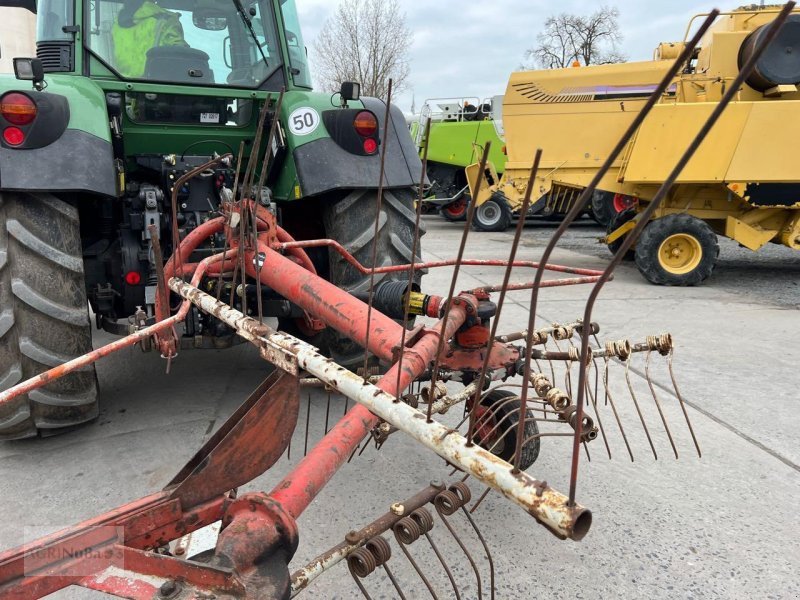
[[87, 0, 283, 88]]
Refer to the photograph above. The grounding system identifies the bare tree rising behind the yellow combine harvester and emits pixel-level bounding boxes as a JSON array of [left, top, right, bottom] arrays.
[[525, 6, 626, 69]]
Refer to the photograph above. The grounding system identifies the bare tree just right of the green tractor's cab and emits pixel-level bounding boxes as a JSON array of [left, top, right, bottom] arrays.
[[314, 0, 412, 98]]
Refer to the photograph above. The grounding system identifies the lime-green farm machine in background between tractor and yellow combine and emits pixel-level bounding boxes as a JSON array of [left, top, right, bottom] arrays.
[[409, 96, 506, 230]]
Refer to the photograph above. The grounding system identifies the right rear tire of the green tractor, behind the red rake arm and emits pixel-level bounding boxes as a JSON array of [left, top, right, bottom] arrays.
[[322, 189, 425, 369]]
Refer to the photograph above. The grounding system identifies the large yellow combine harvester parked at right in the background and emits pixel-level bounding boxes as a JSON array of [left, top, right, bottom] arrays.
[[468, 6, 800, 285]]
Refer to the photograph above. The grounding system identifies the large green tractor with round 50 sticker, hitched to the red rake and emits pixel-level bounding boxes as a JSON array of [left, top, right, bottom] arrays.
[[0, 0, 421, 439]]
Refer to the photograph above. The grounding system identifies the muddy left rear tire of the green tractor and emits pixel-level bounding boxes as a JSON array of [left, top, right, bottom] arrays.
[[0, 192, 98, 440]]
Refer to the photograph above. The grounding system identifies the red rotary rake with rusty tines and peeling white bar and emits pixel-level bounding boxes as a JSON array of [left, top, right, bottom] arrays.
[[0, 3, 794, 600]]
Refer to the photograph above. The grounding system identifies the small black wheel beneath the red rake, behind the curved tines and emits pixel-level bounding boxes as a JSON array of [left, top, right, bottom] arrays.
[[473, 390, 540, 471]]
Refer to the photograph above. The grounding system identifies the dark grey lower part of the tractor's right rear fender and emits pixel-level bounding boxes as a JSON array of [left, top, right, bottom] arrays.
[[293, 98, 422, 196]]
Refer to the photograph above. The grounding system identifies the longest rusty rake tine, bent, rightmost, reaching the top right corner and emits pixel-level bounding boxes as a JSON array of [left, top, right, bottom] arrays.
[[569, 1, 795, 503]]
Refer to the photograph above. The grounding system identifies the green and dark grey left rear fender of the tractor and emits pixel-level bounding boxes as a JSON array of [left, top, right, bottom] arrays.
[[0, 74, 117, 196]]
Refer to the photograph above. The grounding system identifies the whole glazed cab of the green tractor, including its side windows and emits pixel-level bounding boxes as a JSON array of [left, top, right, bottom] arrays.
[[37, 0, 311, 91]]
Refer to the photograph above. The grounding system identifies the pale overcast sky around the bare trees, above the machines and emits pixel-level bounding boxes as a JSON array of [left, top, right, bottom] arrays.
[[297, 0, 720, 111]]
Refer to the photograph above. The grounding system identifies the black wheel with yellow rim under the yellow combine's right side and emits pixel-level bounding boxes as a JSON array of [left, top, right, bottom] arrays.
[[636, 215, 719, 286]]
